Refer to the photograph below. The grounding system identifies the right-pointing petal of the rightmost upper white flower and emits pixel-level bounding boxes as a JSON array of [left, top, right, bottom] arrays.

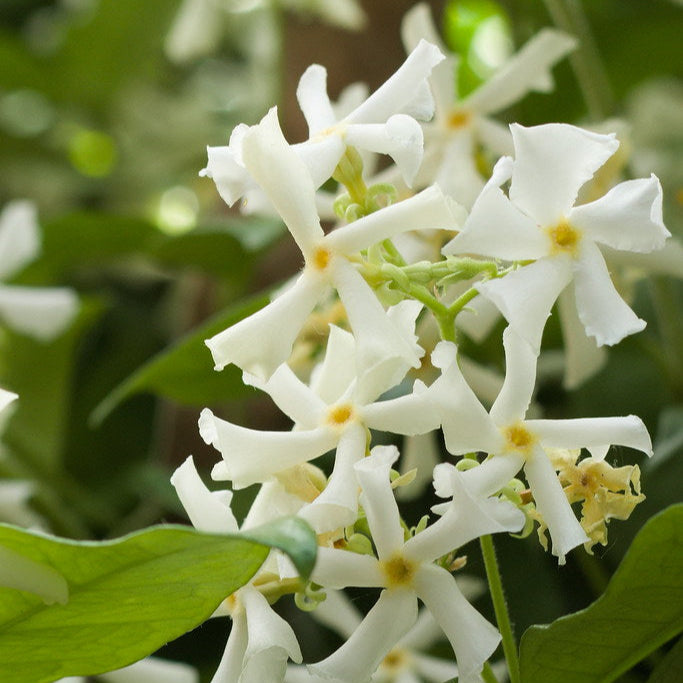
[[567, 175, 671, 252]]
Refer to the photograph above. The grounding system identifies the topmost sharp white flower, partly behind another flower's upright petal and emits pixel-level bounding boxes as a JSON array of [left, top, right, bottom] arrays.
[[200, 41, 443, 205]]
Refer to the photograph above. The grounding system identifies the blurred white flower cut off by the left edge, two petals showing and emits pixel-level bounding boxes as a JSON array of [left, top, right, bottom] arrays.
[[0, 200, 78, 341]]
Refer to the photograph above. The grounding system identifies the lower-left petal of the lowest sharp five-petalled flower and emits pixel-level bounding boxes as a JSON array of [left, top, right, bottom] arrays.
[[308, 590, 417, 683]]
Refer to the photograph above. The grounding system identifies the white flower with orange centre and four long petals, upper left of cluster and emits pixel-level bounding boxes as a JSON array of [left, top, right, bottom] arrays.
[[206, 110, 459, 378]]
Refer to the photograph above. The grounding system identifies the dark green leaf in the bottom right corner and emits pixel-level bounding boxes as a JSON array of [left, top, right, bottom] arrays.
[[520, 504, 683, 683]]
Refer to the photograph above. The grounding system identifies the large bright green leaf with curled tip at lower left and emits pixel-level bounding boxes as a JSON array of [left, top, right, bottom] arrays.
[[0, 519, 316, 683]]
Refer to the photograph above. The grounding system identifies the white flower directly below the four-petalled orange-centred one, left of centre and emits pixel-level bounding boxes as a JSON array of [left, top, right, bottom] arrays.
[[199, 314, 439, 532]]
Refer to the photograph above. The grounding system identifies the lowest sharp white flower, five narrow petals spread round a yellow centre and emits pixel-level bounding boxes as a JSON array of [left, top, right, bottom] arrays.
[[309, 446, 523, 683]]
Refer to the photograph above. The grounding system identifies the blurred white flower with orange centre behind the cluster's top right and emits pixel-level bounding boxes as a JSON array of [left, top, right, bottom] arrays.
[[401, 3, 576, 207]]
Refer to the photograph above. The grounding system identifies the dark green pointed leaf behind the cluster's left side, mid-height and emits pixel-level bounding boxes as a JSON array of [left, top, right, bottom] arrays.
[[91, 295, 268, 424]]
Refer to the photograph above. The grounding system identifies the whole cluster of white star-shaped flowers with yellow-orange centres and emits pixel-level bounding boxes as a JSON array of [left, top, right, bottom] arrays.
[[173, 6, 669, 683]]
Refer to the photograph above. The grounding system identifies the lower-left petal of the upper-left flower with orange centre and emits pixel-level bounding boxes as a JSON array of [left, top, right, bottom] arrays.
[[206, 269, 326, 379]]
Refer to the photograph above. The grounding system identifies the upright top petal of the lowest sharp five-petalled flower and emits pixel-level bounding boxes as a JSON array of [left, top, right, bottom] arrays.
[[355, 446, 403, 560]]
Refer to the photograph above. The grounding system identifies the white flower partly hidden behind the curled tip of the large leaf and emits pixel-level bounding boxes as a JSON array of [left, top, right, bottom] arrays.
[[171, 457, 301, 683]]
